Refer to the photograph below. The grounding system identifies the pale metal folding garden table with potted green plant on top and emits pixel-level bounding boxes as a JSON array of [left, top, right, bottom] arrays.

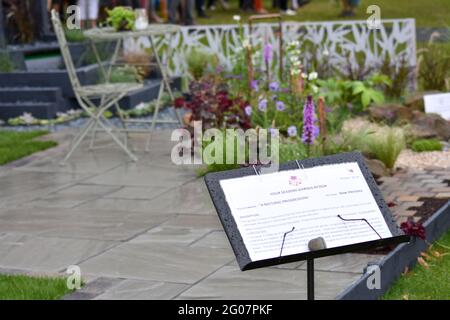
[[84, 24, 182, 151]]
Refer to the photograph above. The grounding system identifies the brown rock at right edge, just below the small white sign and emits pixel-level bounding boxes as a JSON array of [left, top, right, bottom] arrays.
[[411, 111, 450, 141]]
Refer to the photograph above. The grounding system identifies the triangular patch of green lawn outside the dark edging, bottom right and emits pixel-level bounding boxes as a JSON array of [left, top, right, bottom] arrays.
[[383, 231, 450, 300]]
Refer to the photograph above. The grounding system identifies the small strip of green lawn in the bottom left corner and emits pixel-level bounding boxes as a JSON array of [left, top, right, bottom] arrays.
[[0, 275, 71, 300]]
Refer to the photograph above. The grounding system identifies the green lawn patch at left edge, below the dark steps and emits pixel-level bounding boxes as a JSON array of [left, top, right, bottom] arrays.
[[0, 131, 57, 165]]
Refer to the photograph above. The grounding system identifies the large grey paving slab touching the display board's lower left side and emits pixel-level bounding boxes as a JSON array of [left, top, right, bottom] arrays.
[[80, 243, 234, 284]]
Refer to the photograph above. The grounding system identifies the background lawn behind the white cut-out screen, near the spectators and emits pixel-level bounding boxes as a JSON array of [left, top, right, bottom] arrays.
[[198, 0, 450, 27]]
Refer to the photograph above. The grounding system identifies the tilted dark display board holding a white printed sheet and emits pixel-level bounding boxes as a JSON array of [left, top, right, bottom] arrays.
[[205, 152, 409, 298]]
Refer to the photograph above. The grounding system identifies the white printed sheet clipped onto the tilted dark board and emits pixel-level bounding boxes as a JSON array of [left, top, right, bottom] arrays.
[[220, 162, 392, 261]]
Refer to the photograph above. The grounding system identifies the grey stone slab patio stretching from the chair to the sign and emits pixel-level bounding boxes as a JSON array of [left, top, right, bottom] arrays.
[[0, 131, 446, 299]]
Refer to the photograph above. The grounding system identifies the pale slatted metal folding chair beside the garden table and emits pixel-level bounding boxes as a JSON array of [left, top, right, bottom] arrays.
[[52, 10, 143, 164]]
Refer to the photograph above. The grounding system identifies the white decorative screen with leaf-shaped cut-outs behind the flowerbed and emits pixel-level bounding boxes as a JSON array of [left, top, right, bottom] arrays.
[[126, 19, 416, 84]]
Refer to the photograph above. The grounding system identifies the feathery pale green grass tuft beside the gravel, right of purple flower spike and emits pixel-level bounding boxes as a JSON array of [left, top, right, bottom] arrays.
[[366, 127, 406, 170]]
